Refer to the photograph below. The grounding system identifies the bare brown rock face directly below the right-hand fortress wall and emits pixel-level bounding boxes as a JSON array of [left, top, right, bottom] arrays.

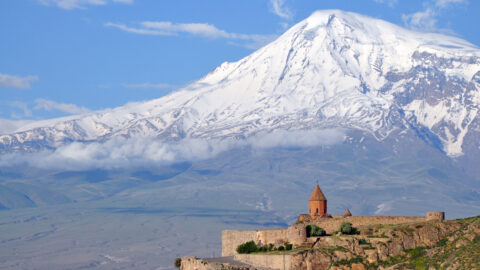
[[291, 221, 464, 270]]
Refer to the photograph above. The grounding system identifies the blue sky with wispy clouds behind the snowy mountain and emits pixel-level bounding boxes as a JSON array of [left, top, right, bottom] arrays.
[[0, 0, 480, 122]]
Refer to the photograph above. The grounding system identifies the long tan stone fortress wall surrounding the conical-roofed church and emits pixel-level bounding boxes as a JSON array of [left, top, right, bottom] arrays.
[[222, 212, 445, 256]]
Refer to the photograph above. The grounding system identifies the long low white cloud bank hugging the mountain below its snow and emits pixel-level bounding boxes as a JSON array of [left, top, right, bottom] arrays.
[[0, 129, 345, 171]]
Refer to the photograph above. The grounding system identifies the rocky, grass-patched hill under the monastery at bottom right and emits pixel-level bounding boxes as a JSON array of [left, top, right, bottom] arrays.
[[180, 216, 480, 270]]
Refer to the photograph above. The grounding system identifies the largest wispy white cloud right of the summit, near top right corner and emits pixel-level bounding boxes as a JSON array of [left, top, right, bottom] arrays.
[[402, 0, 468, 32]]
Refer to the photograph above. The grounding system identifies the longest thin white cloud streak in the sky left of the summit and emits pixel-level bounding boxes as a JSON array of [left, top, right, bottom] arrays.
[[105, 21, 276, 48]]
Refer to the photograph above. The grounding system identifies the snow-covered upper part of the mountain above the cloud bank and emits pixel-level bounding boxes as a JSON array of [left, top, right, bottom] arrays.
[[0, 10, 480, 156]]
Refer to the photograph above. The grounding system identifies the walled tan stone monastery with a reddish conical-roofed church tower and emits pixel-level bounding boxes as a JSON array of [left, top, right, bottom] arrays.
[[182, 185, 445, 269]]
